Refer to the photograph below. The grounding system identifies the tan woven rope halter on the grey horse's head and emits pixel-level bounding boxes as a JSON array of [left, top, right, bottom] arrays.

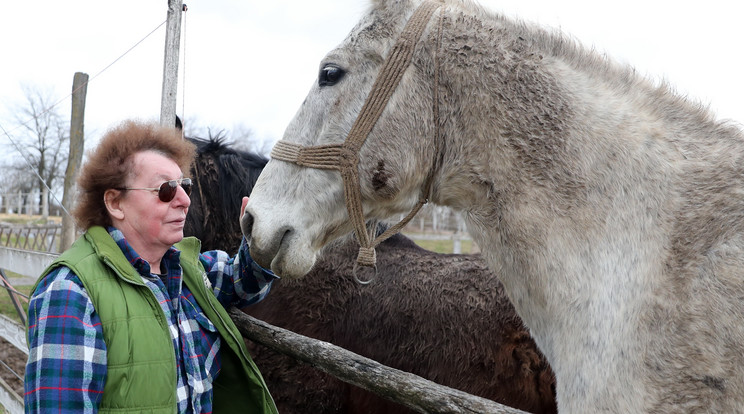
[[271, 0, 442, 283]]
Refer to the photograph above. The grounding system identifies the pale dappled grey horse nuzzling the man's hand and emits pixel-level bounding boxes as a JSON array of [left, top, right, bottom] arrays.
[[247, 0, 744, 413]]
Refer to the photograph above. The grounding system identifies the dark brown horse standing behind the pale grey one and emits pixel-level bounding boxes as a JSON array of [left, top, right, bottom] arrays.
[[186, 139, 556, 414]]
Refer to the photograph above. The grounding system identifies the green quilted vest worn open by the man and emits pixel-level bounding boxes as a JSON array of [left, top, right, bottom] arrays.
[[34, 227, 277, 414]]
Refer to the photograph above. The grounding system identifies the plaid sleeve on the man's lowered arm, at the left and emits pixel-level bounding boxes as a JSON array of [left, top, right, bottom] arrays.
[[24, 267, 107, 413]]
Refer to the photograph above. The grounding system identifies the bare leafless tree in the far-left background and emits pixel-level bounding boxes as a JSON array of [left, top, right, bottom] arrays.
[[10, 85, 70, 213]]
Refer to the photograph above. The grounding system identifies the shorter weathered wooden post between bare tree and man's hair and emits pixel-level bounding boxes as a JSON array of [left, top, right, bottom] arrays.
[[59, 72, 88, 252]]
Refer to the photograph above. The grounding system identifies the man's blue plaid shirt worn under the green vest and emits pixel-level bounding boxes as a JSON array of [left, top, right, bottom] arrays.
[[24, 227, 277, 413]]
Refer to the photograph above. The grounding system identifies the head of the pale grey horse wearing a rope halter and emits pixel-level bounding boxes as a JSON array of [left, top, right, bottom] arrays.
[[242, 1, 439, 278]]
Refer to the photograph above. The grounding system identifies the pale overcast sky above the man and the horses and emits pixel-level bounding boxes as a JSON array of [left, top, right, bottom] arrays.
[[0, 0, 744, 160]]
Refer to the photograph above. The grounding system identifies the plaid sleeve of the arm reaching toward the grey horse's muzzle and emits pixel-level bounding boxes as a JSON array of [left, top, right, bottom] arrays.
[[201, 238, 279, 308]]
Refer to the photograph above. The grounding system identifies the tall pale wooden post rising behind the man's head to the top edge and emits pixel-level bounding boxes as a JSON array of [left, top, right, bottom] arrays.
[[160, 0, 183, 127]]
